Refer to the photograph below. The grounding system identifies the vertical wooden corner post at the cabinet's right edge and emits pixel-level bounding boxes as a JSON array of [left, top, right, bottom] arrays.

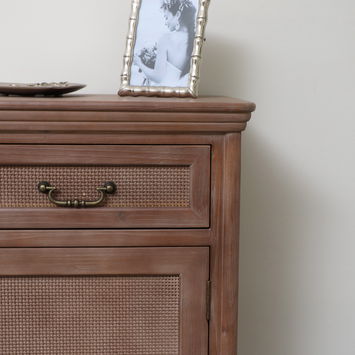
[[210, 134, 241, 355]]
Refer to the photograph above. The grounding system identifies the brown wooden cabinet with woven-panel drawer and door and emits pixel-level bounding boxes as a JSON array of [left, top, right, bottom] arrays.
[[0, 95, 255, 355]]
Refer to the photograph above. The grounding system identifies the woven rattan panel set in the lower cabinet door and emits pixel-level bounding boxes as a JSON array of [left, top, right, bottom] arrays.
[[0, 276, 180, 355]]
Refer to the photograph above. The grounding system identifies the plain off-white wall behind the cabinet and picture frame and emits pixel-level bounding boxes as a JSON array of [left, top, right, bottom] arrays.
[[0, 0, 355, 355]]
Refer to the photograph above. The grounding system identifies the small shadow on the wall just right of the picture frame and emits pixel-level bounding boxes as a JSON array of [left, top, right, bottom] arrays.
[[200, 35, 248, 96]]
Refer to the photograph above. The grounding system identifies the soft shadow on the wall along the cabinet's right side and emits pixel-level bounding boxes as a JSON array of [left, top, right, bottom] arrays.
[[238, 130, 321, 355]]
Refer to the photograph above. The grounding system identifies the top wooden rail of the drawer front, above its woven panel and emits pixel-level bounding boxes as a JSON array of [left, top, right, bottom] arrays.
[[0, 144, 210, 166]]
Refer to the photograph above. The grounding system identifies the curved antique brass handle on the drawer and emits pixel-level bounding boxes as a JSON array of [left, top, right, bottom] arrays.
[[38, 181, 117, 208]]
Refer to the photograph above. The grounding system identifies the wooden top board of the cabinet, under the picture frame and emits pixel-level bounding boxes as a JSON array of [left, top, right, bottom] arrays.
[[0, 95, 255, 113]]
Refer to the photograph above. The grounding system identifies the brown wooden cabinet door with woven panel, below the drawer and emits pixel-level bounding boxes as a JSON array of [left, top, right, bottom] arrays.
[[0, 247, 209, 355]]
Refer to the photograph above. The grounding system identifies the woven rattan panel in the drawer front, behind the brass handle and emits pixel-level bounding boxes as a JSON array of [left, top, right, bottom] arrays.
[[0, 166, 190, 208]]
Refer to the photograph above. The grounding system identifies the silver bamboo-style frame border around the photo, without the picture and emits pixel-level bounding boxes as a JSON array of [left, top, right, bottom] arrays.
[[118, 0, 210, 98]]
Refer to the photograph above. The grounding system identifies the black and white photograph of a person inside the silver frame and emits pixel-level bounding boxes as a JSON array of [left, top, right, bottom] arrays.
[[129, 0, 199, 87]]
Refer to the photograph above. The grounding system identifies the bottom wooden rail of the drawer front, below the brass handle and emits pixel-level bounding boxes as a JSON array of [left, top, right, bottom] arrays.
[[0, 207, 209, 229]]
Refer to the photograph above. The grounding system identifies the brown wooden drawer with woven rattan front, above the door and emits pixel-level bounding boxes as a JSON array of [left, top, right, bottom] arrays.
[[0, 145, 210, 229]]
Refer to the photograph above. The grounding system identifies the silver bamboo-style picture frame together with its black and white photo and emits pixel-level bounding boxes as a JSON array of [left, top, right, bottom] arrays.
[[118, 0, 210, 98]]
